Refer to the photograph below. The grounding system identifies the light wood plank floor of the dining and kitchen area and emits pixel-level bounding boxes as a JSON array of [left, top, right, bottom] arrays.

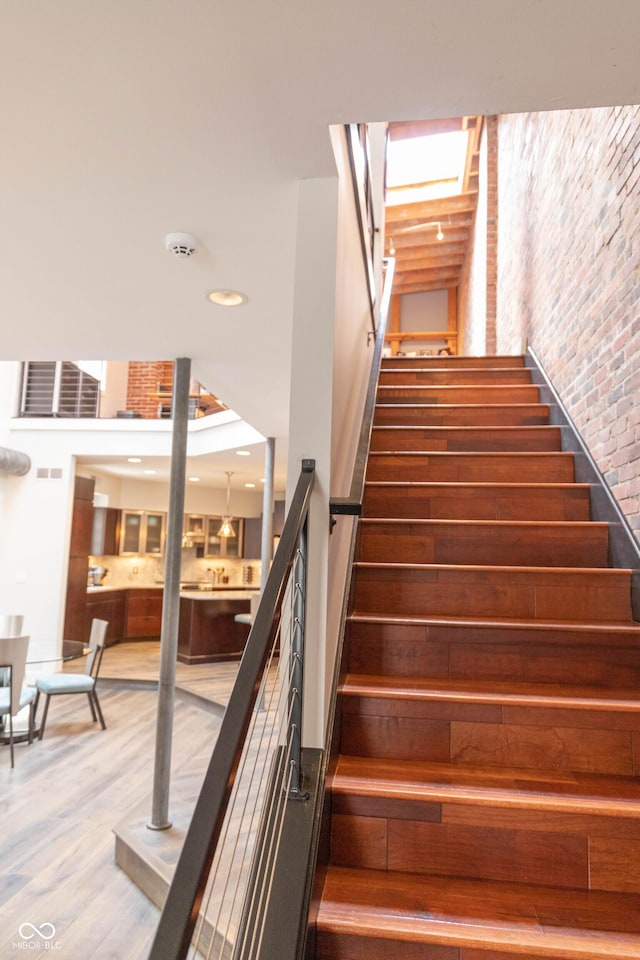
[[0, 643, 238, 960]]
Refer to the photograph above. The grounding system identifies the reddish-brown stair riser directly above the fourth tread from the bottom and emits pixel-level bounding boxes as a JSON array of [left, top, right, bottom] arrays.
[[354, 566, 631, 622]]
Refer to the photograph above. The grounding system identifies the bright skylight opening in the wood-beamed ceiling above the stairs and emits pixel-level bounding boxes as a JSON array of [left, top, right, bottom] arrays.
[[387, 130, 469, 204]]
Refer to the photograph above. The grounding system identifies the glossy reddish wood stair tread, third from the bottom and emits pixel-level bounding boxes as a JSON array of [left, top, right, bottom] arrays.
[[339, 673, 640, 713]]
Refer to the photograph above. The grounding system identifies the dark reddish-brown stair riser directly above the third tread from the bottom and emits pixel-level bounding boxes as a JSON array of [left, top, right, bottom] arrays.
[[349, 622, 640, 689]]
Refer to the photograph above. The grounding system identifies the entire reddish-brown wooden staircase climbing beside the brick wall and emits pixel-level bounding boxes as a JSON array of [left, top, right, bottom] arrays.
[[315, 357, 640, 960]]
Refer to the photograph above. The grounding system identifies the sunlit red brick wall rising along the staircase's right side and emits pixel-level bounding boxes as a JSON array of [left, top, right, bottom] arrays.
[[497, 107, 640, 534]]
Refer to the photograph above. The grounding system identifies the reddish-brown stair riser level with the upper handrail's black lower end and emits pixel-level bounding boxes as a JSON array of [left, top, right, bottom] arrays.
[[363, 483, 591, 521]]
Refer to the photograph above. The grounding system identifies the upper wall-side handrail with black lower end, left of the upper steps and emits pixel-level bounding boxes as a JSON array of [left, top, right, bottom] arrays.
[[329, 251, 396, 516]]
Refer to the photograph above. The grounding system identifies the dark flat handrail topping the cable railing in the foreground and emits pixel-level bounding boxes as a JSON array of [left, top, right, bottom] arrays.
[[149, 460, 315, 960]]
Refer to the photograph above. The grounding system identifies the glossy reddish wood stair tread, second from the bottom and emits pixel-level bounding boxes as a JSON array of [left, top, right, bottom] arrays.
[[330, 755, 640, 817]]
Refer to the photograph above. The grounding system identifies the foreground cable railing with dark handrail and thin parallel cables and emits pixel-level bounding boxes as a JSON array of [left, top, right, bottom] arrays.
[[149, 460, 315, 960]]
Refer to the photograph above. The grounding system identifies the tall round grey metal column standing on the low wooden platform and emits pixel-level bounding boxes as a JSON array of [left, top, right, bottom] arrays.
[[147, 357, 191, 830]]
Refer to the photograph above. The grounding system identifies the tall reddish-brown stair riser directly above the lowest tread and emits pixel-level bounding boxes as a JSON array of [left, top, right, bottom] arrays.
[[331, 794, 640, 893]]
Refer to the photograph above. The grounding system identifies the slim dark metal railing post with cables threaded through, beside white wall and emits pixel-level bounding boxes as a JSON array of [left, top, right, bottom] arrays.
[[289, 517, 309, 799]]
